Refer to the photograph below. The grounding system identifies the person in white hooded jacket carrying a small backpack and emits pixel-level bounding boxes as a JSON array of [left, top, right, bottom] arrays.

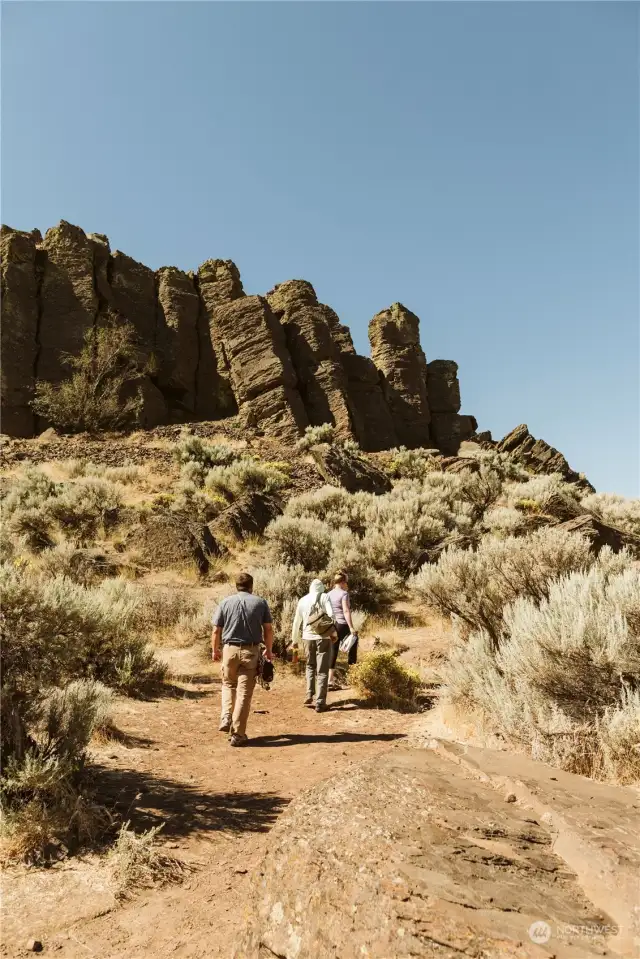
[[291, 579, 338, 713]]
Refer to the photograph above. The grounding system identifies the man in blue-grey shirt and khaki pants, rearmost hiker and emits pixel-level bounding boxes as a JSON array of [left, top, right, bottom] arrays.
[[211, 573, 273, 746]]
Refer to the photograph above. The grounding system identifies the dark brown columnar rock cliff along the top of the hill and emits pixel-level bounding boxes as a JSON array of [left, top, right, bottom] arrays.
[[1, 220, 476, 454]]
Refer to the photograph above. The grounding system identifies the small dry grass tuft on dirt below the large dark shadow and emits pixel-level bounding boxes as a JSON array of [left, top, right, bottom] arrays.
[[109, 822, 188, 899]]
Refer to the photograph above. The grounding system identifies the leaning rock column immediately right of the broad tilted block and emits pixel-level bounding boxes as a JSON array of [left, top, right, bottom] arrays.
[[267, 280, 353, 439]]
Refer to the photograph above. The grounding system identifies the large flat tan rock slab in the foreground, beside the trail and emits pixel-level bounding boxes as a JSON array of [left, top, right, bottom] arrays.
[[235, 749, 624, 959]]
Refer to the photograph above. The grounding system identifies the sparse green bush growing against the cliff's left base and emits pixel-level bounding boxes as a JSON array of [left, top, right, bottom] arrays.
[[33, 322, 144, 433]]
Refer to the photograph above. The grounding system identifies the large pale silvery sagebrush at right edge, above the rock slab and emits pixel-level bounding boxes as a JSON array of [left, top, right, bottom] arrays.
[[443, 558, 640, 782]]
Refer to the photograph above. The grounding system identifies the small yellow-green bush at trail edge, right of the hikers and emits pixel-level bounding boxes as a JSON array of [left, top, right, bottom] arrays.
[[348, 649, 422, 712]]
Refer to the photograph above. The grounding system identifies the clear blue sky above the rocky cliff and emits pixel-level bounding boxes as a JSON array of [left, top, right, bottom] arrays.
[[2, 2, 640, 495]]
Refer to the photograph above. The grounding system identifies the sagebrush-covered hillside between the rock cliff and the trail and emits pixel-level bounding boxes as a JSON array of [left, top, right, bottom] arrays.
[[0, 419, 640, 861]]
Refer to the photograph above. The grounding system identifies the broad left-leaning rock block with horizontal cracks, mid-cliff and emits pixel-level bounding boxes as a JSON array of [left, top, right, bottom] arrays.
[[215, 296, 309, 440]]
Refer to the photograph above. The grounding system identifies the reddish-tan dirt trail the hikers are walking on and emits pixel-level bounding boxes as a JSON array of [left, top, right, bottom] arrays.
[[1, 650, 414, 959]]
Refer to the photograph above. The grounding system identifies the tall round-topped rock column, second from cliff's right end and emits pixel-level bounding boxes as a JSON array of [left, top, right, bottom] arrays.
[[369, 303, 430, 448]]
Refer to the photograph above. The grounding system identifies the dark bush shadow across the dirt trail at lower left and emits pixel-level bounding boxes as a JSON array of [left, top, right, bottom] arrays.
[[92, 765, 289, 838]]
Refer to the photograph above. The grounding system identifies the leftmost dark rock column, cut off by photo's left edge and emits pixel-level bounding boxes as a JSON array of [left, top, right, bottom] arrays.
[[0, 226, 38, 436]]
